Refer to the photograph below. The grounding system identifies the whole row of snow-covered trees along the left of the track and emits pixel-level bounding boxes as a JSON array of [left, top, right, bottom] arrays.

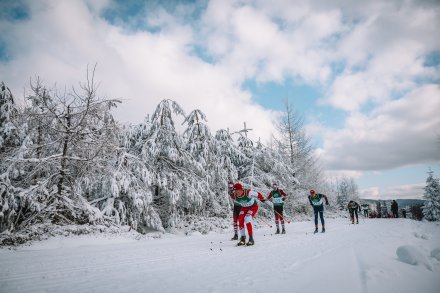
[[0, 69, 362, 243]]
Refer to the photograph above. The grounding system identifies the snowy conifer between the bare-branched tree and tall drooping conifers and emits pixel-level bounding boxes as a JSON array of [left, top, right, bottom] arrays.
[[101, 117, 163, 233]]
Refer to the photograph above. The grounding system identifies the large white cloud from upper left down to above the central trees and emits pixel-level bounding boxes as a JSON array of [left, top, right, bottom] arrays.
[[0, 1, 278, 140]]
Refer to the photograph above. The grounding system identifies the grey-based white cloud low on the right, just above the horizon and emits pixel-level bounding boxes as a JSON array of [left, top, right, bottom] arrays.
[[318, 85, 440, 170]]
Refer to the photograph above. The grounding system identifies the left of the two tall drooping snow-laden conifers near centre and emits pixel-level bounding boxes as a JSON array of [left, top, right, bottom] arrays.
[[142, 100, 209, 228]]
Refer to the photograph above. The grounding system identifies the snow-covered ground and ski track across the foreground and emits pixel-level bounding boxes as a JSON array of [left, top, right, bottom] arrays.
[[0, 219, 440, 293]]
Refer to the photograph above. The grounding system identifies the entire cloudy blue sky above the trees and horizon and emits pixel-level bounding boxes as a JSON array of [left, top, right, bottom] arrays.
[[0, 0, 440, 199]]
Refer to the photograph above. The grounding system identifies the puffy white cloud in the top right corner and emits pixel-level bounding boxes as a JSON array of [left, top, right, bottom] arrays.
[[325, 1, 440, 111]]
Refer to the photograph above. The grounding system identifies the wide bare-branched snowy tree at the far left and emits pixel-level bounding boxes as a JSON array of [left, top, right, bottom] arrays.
[[1, 71, 118, 233]]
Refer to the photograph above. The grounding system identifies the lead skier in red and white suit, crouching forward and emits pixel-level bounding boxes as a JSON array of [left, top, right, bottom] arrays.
[[232, 183, 266, 246]]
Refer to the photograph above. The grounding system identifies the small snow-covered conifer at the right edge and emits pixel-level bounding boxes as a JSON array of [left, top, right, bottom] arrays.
[[423, 171, 440, 221]]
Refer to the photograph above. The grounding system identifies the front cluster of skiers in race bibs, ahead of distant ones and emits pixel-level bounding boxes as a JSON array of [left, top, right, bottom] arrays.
[[228, 181, 329, 246]]
